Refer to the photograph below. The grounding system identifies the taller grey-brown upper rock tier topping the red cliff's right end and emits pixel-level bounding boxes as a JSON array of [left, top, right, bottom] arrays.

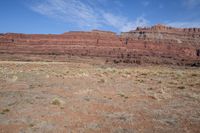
[[122, 25, 200, 46]]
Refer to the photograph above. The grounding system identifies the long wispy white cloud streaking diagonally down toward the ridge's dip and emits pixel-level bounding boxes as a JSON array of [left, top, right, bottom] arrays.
[[30, 0, 148, 31]]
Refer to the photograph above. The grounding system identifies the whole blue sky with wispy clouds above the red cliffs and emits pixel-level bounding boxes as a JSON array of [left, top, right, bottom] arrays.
[[0, 0, 200, 33]]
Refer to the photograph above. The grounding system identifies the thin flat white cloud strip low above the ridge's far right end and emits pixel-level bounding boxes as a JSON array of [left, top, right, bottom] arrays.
[[167, 22, 200, 28]]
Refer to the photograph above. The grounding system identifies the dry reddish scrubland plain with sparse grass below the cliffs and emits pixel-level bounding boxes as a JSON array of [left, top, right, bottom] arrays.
[[0, 62, 200, 133]]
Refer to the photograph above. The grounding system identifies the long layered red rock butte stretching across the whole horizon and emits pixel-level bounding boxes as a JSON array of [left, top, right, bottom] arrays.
[[0, 24, 200, 66]]
